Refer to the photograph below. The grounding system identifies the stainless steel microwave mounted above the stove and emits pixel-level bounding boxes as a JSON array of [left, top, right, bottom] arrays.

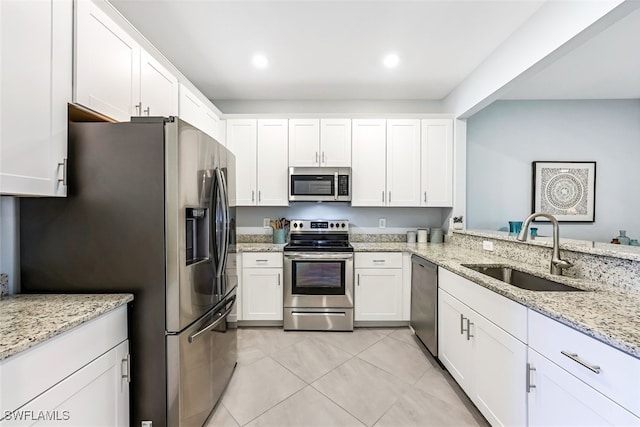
[[289, 167, 351, 202]]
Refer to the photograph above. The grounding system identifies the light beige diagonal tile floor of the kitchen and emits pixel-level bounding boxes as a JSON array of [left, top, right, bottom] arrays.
[[207, 328, 488, 427]]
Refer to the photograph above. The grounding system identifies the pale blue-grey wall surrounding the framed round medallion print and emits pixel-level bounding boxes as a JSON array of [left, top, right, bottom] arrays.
[[467, 100, 640, 242]]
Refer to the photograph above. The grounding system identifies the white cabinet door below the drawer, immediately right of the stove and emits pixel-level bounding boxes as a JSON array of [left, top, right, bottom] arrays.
[[353, 268, 403, 321]]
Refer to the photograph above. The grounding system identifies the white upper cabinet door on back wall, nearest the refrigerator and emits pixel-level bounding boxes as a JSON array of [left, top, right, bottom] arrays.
[[227, 119, 255, 206]]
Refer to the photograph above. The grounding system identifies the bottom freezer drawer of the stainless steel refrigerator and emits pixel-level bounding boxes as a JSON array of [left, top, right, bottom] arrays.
[[167, 293, 237, 427]]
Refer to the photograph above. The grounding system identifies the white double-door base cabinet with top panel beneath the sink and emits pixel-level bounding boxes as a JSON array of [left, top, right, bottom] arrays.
[[438, 269, 527, 426]]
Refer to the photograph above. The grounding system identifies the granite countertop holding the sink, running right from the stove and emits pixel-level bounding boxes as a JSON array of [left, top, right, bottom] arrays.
[[352, 243, 640, 358]]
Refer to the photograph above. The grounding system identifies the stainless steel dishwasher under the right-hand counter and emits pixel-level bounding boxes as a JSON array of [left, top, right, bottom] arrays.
[[411, 255, 438, 358]]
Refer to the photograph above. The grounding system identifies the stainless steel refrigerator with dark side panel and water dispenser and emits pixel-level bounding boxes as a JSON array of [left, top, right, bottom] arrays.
[[20, 117, 237, 427]]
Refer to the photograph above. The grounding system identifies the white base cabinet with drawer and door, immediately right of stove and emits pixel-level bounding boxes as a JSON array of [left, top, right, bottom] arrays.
[[354, 252, 404, 321]]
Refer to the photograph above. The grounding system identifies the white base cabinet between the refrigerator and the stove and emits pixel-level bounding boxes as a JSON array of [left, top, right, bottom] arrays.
[[242, 252, 283, 321]]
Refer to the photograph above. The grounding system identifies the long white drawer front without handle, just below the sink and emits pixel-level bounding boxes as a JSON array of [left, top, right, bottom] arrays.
[[438, 268, 527, 343]]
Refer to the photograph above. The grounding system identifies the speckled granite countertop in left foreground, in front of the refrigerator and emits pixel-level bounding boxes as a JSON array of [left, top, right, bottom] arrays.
[[0, 294, 133, 361]]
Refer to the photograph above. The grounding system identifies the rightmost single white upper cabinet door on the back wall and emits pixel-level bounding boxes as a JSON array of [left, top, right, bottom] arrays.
[[420, 119, 453, 207]]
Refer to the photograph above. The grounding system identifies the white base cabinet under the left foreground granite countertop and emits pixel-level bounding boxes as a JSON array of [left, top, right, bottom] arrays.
[[0, 306, 131, 427]]
